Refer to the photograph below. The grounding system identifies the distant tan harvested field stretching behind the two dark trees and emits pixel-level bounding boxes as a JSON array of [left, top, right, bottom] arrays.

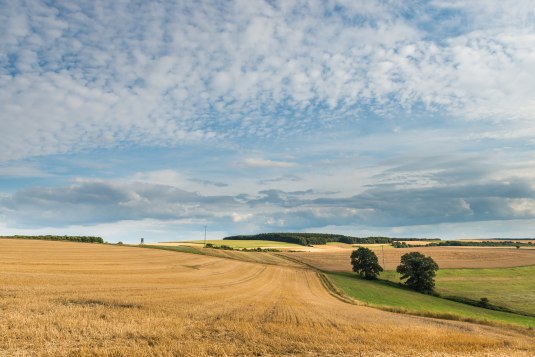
[[277, 245, 535, 271]]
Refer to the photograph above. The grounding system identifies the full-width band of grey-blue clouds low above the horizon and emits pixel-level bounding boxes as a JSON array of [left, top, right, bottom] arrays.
[[0, 170, 535, 229]]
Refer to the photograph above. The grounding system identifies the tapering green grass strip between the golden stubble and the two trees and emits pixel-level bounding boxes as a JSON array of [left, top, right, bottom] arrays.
[[328, 273, 535, 328]]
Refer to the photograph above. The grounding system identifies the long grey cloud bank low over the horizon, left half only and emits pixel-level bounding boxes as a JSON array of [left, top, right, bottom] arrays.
[[0, 181, 236, 226]]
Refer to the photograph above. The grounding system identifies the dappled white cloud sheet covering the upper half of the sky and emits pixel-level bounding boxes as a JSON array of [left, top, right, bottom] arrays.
[[0, 1, 535, 160]]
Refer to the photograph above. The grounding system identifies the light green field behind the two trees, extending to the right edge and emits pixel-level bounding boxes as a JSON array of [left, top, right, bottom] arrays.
[[381, 265, 535, 314]]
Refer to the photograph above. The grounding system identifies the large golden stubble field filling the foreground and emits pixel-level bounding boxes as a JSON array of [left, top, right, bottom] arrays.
[[0, 239, 535, 356]]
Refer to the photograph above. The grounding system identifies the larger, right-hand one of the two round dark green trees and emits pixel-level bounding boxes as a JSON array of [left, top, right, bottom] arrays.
[[396, 252, 438, 294]]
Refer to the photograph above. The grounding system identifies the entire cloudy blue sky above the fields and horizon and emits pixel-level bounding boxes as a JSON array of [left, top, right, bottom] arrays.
[[0, 0, 535, 243]]
